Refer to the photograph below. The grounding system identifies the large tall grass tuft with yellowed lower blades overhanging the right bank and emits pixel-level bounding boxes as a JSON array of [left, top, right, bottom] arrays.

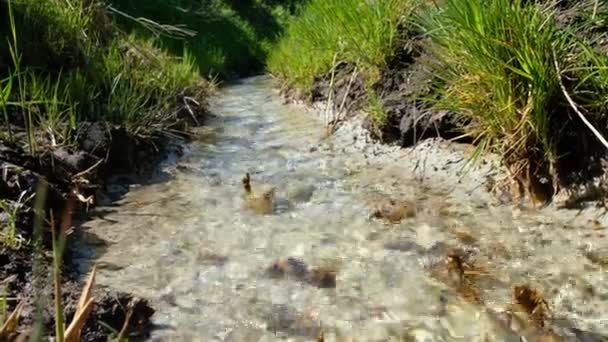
[[422, 0, 566, 180]]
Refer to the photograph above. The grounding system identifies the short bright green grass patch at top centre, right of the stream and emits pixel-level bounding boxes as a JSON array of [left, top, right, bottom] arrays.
[[267, 0, 415, 93]]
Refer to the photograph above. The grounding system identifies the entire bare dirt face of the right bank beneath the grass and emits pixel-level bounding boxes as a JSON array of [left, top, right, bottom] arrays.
[[280, 33, 608, 209]]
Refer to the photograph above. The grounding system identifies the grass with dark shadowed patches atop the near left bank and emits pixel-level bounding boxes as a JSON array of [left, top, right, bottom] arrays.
[[0, 0, 207, 151]]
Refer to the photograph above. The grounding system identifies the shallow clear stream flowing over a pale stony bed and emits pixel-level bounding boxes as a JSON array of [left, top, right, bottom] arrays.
[[84, 77, 608, 341]]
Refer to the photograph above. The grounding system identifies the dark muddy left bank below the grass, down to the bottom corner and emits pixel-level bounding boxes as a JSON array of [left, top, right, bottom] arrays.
[[0, 108, 204, 341]]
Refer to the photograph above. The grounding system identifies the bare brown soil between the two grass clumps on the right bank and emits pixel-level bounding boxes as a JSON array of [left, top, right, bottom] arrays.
[[300, 31, 469, 147]]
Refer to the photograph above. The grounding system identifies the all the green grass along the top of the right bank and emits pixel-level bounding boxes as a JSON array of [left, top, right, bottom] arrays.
[[268, 0, 608, 198]]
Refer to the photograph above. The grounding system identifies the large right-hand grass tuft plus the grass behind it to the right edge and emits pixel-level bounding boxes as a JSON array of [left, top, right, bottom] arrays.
[[421, 0, 608, 195]]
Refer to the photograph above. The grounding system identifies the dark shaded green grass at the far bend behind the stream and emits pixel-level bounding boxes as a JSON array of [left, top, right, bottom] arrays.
[[111, 0, 300, 78]]
